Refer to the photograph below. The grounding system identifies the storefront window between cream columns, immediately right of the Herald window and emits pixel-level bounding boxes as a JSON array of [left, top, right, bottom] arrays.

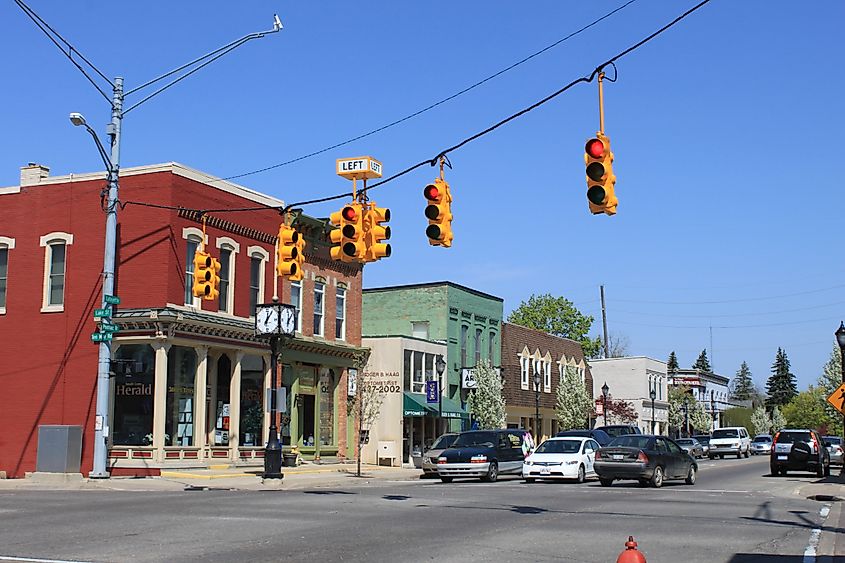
[[164, 346, 197, 447]]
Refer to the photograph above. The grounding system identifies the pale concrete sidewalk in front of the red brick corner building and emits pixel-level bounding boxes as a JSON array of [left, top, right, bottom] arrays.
[[0, 463, 422, 492]]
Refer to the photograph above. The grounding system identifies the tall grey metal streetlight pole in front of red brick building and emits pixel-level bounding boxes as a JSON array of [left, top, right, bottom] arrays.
[[88, 76, 123, 479]]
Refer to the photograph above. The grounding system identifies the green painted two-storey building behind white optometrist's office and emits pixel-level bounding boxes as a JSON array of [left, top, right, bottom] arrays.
[[362, 282, 503, 436]]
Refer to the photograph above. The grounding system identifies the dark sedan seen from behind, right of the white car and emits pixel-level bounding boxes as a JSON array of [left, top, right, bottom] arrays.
[[594, 434, 698, 487]]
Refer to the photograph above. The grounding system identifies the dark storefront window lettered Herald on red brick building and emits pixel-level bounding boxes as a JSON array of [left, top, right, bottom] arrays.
[[112, 344, 155, 446]]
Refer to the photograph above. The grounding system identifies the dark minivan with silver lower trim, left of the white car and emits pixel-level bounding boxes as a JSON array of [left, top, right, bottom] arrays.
[[437, 430, 533, 483]]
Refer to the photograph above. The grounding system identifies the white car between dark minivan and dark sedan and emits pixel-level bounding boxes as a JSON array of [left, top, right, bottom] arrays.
[[522, 436, 599, 483]]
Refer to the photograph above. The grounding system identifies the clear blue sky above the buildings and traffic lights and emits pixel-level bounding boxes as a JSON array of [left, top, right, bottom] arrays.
[[0, 0, 845, 394]]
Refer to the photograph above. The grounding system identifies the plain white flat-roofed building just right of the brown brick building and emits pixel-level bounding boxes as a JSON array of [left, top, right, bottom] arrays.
[[589, 356, 669, 434]]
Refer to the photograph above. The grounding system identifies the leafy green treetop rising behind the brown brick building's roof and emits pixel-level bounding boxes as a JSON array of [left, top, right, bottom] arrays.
[[508, 293, 601, 358]]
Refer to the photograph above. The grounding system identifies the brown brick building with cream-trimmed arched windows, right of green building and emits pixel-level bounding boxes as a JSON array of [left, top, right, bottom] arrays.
[[502, 323, 593, 437]]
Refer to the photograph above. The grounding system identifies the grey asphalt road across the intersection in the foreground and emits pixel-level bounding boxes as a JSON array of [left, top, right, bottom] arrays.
[[0, 458, 840, 563]]
